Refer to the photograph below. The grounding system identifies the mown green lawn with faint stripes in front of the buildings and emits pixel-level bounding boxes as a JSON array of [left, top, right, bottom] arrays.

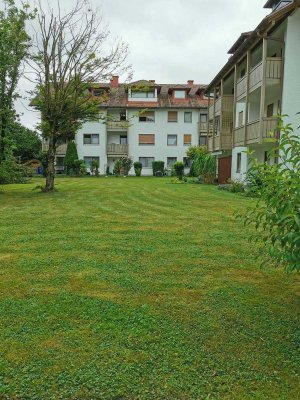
[[0, 177, 300, 400]]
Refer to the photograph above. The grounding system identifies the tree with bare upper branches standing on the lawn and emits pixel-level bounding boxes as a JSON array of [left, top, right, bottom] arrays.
[[31, 0, 128, 191]]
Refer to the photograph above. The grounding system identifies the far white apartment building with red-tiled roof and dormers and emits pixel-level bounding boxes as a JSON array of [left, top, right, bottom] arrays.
[[48, 76, 208, 175]]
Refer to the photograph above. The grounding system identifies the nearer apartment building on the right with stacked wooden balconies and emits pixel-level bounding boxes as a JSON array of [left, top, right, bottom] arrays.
[[206, 0, 300, 182]]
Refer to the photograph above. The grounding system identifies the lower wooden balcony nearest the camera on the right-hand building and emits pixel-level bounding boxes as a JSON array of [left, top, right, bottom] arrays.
[[234, 117, 278, 146]]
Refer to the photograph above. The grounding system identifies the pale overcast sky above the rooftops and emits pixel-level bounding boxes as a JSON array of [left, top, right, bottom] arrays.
[[18, 0, 269, 127]]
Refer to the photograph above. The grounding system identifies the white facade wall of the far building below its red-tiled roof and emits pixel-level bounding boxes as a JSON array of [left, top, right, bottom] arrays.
[[76, 109, 205, 175]]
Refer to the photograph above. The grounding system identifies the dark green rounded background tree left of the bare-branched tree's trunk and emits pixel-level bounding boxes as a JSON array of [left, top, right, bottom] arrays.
[[6, 122, 42, 161]]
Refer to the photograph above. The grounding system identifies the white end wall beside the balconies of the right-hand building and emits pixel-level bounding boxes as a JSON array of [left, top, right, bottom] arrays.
[[282, 8, 300, 128]]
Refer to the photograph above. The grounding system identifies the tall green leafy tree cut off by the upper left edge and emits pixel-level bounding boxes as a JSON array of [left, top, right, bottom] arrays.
[[0, 0, 34, 162]]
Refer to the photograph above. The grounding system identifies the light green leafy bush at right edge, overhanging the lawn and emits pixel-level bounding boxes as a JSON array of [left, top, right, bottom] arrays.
[[245, 115, 300, 271]]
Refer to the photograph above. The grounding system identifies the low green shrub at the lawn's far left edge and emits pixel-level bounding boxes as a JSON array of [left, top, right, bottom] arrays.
[[0, 158, 31, 185]]
